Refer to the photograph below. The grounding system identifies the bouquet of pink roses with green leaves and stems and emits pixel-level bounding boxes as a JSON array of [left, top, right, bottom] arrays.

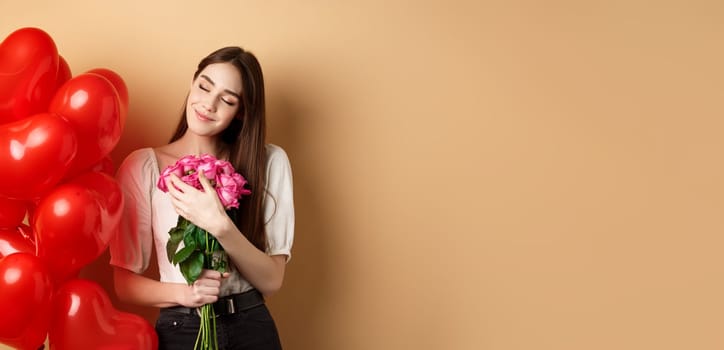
[[157, 154, 251, 349]]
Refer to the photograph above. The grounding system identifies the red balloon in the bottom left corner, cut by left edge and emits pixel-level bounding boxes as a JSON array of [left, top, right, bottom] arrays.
[[0, 253, 53, 349]]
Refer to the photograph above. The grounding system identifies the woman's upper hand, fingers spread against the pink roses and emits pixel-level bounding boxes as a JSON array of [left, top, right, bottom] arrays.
[[166, 173, 228, 236]]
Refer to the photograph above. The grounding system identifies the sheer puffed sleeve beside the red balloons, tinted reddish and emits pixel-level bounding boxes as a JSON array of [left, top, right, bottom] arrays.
[[110, 148, 157, 273]]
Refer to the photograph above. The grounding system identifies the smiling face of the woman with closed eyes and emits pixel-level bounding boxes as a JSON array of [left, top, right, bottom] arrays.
[[186, 63, 241, 136]]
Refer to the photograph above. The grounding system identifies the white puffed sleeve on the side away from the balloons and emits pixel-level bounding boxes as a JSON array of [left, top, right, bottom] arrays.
[[264, 144, 294, 262]]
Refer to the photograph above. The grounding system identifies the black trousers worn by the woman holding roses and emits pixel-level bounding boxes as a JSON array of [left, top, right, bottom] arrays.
[[156, 304, 282, 350]]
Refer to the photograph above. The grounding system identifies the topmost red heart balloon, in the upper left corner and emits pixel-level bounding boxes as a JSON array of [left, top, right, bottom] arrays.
[[0, 28, 59, 123]]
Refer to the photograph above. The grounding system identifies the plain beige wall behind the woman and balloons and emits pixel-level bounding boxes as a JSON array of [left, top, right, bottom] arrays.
[[0, 0, 724, 350]]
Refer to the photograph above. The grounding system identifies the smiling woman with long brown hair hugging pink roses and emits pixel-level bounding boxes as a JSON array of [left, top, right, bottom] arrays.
[[110, 47, 294, 349]]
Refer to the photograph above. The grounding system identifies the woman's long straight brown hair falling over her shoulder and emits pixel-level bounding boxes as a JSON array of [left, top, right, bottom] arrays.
[[169, 46, 267, 251]]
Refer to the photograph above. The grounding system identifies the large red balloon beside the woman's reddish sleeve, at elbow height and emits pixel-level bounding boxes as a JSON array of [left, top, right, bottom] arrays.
[[31, 183, 108, 283]]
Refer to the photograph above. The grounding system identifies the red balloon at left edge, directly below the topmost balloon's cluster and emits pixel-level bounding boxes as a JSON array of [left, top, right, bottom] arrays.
[[0, 113, 78, 199]]
